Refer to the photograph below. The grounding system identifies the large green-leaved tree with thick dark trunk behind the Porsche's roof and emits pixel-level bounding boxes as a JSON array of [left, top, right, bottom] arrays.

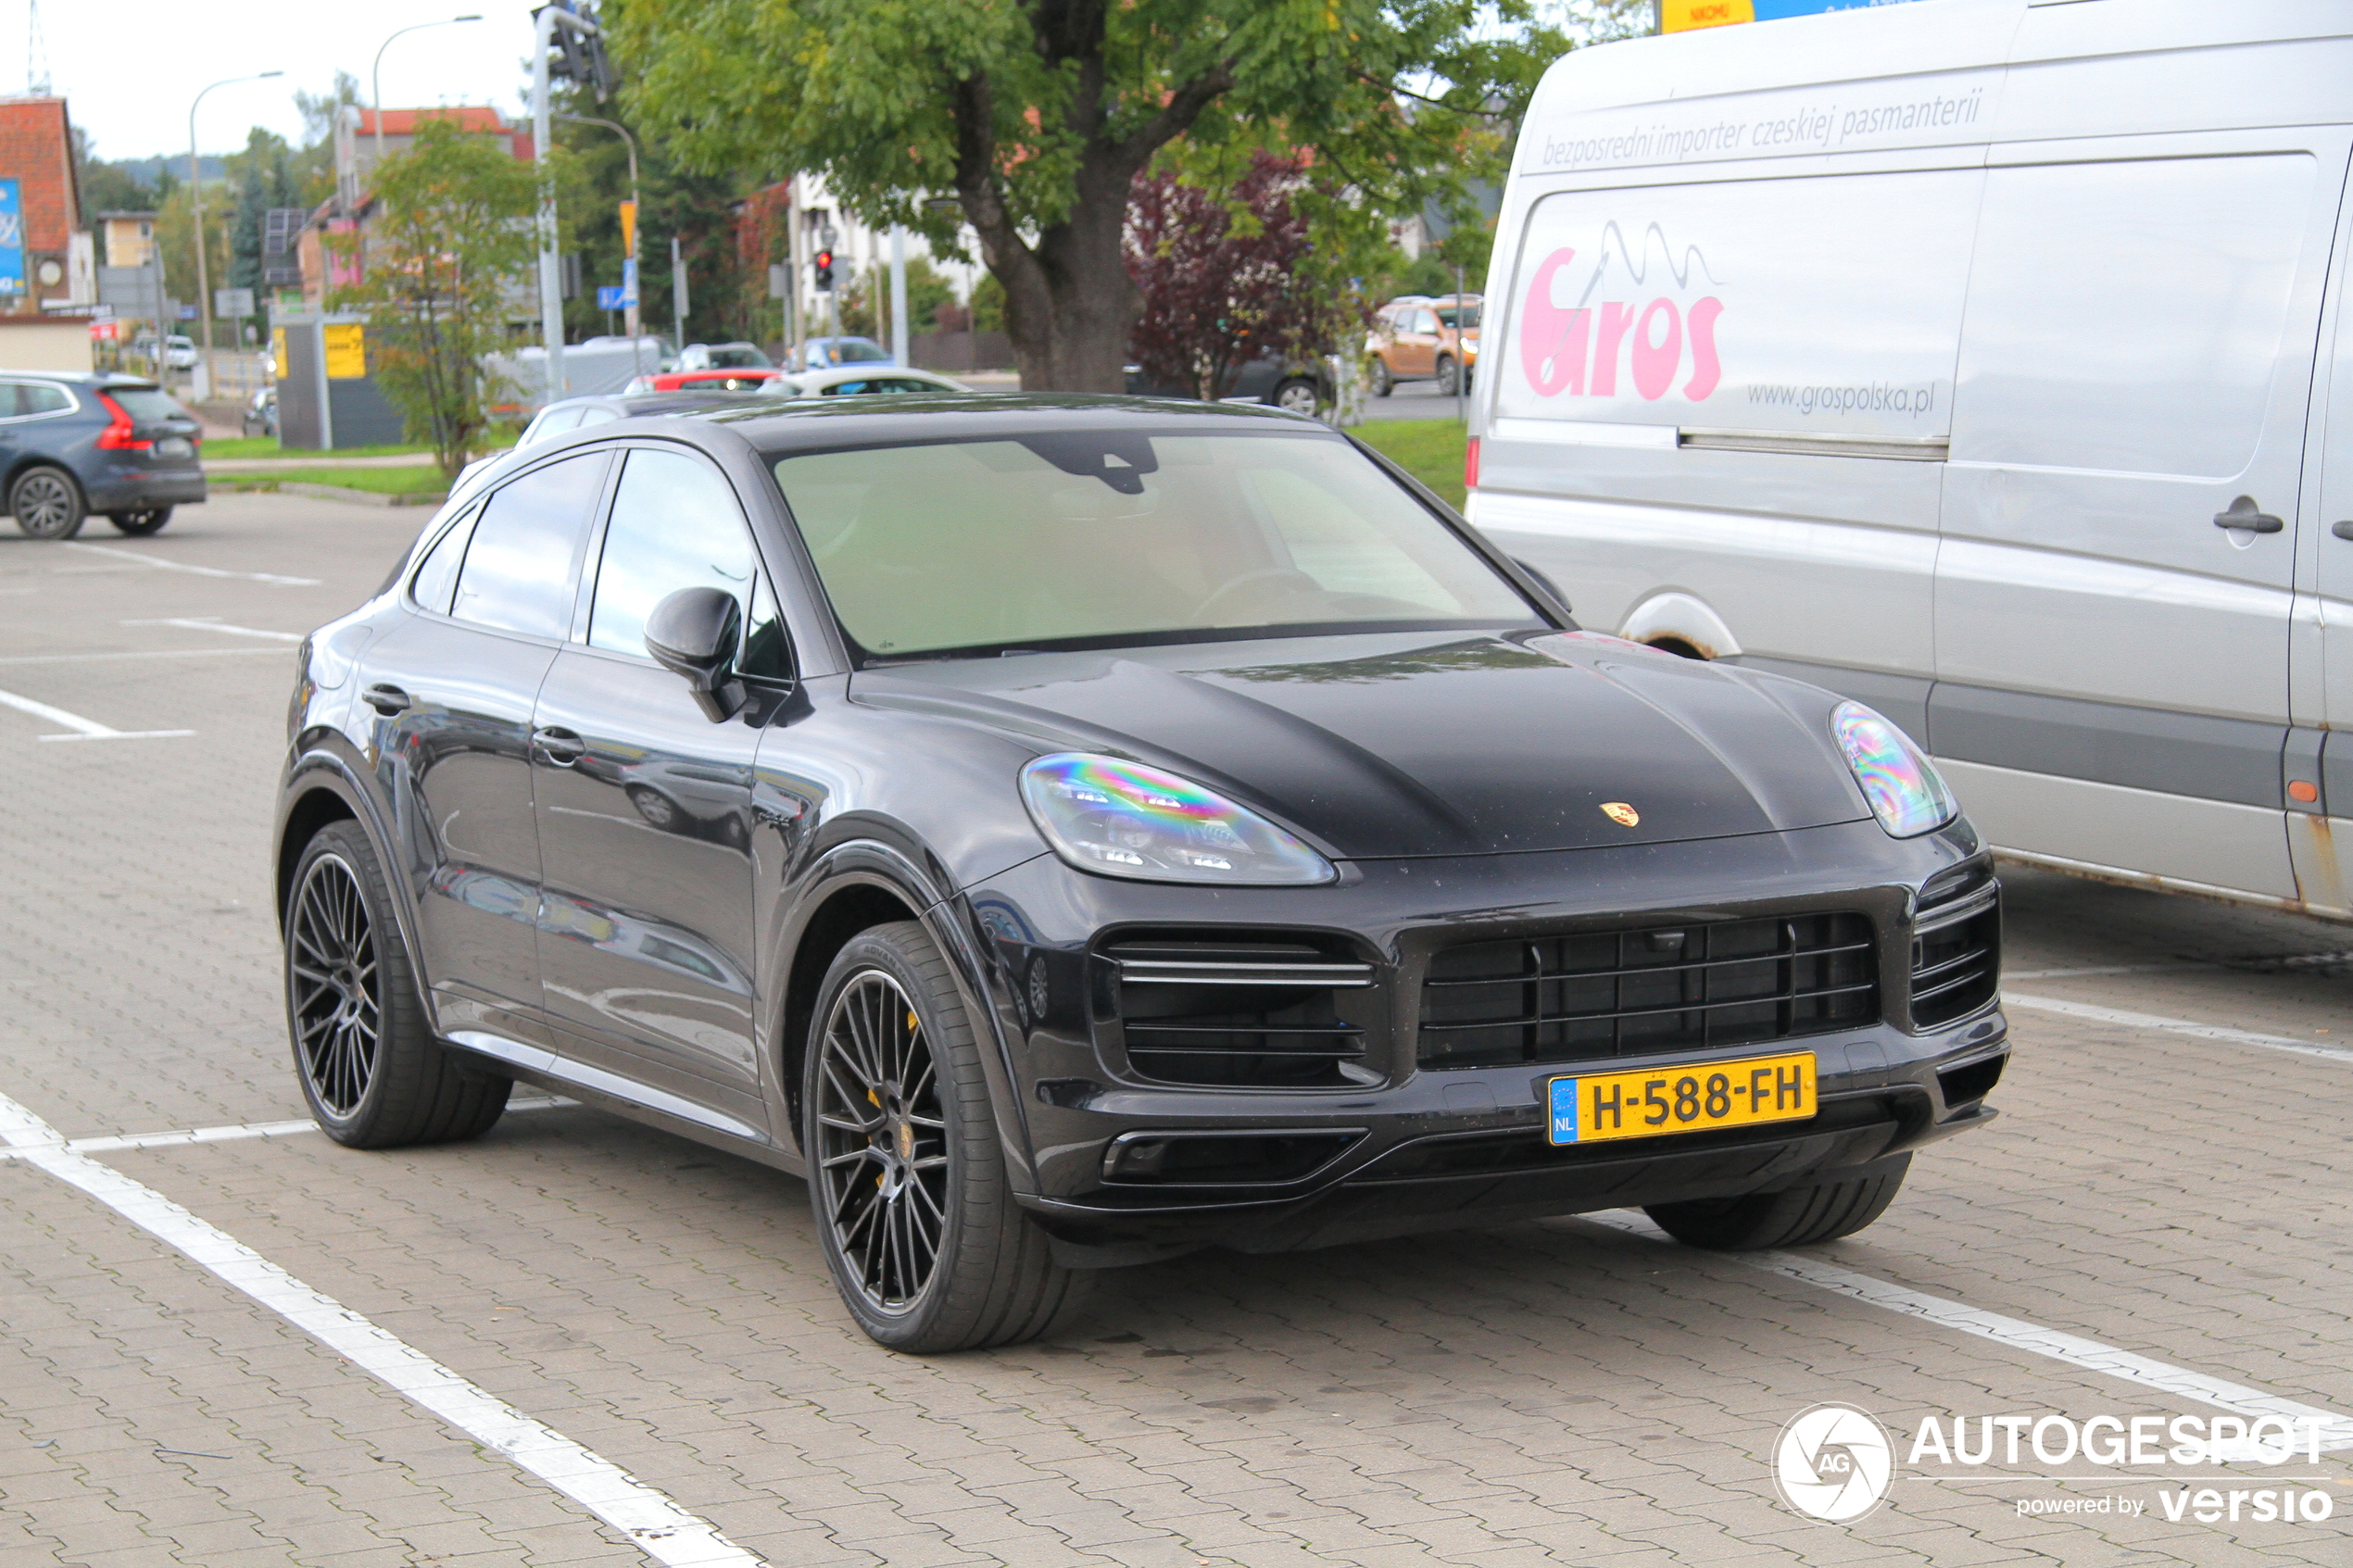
[[605, 0, 1569, 390]]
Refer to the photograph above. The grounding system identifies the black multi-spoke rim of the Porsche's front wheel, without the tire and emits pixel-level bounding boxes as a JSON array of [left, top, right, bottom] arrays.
[[816, 969, 949, 1311]]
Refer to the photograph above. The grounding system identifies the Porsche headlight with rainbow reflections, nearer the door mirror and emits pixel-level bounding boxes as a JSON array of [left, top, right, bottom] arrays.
[[1021, 752, 1339, 886]]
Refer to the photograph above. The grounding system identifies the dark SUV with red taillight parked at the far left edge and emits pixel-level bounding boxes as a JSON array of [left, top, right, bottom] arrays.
[[0, 371, 205, 538]]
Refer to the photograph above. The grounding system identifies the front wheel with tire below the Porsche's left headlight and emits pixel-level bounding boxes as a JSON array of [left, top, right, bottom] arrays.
[[800, 922, 1092, 1357]]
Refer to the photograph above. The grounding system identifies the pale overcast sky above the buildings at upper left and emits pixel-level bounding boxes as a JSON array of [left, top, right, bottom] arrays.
[[13, 0, 546, 157]]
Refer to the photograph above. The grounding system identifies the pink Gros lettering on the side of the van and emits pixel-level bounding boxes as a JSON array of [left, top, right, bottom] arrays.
[[1520, 249, 1725, 402]]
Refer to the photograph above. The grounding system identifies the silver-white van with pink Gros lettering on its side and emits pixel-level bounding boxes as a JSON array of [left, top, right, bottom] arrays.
[[1471, 0, 2353, 917]]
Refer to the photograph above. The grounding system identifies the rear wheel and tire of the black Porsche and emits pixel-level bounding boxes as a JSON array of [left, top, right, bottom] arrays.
[[284, 821, 513, 1149]]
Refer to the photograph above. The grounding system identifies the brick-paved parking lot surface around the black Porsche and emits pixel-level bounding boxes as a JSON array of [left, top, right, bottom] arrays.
[[0, 496, 2353, 1568]]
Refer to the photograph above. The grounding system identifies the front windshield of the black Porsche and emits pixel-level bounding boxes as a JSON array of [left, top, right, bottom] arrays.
[[776, 430, 1541, 659]]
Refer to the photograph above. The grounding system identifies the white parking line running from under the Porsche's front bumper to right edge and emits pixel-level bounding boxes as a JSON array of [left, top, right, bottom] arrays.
[[1577, 1210, 2353, 1450]]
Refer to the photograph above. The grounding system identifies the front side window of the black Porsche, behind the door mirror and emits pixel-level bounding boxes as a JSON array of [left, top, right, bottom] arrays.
[[588, 446, 758, 659]]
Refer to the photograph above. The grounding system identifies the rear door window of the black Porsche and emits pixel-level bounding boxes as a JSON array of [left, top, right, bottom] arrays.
[[449, 451, 610, 637]]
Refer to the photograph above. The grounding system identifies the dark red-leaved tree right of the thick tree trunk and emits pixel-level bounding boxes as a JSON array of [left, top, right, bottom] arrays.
[[1127, 153, 1367, 399]]
